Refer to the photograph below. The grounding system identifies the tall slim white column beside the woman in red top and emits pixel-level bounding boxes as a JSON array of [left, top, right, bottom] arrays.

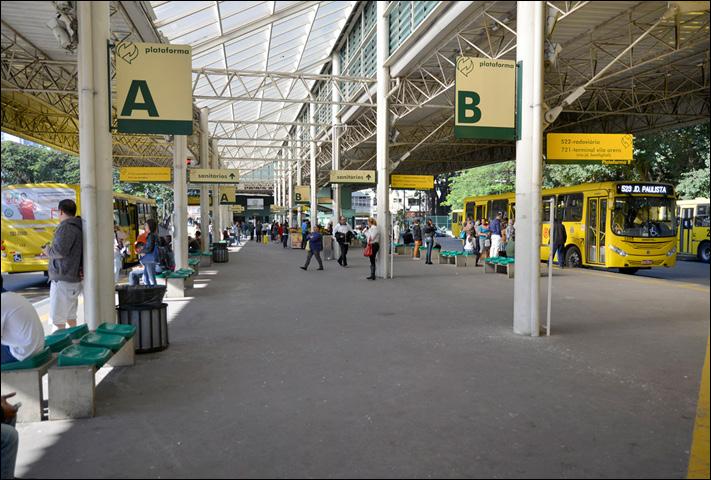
[[375, 2, 391, 278]]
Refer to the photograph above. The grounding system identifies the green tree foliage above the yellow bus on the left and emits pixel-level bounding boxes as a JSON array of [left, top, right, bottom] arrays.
[[2, 141, 79, 185]]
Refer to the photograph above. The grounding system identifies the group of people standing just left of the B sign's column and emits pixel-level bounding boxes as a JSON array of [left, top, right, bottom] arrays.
[[462, 212, 516, 266]]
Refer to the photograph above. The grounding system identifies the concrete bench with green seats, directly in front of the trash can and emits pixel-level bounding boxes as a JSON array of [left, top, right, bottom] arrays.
[[49, 323, 136, 420]]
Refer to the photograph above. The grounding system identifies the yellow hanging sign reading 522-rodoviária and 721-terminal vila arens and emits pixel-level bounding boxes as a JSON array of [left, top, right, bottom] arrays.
[[546, 133, 634, 164]]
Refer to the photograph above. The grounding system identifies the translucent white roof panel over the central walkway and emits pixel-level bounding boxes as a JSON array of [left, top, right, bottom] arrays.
[[150, 1, 356, 163]]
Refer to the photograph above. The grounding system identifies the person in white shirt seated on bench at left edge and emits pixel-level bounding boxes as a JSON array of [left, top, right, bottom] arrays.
[[0, 282, 44, 364]]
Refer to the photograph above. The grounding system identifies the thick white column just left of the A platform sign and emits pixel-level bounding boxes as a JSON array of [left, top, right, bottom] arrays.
[[78, 2, 116, 330]]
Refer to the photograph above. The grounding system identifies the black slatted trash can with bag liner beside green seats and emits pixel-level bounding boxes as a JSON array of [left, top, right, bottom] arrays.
[[116, 303, 169, 353]]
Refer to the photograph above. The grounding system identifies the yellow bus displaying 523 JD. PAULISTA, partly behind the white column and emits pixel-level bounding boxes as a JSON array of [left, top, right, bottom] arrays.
[[464, 182, 677, 273]]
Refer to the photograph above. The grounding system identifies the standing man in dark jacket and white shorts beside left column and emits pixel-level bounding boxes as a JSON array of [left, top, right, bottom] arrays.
[[44, 199, 84, 329]]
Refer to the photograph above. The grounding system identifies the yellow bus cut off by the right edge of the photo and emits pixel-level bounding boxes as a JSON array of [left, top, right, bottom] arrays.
[[676, 198, 711, 263]]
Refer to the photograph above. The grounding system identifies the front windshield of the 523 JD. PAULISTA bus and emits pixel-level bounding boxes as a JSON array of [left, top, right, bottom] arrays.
[[612, 196, 676, 237]]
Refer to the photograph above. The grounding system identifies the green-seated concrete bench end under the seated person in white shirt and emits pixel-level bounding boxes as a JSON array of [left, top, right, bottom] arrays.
[[0, 346, 54, 423]]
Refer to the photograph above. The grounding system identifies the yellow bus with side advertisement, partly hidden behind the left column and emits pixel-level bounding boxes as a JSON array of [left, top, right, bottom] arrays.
[[0, 183, 156, 273]]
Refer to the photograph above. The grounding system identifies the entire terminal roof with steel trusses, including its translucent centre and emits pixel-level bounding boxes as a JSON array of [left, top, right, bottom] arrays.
[[2, 1, 709, 189]]
